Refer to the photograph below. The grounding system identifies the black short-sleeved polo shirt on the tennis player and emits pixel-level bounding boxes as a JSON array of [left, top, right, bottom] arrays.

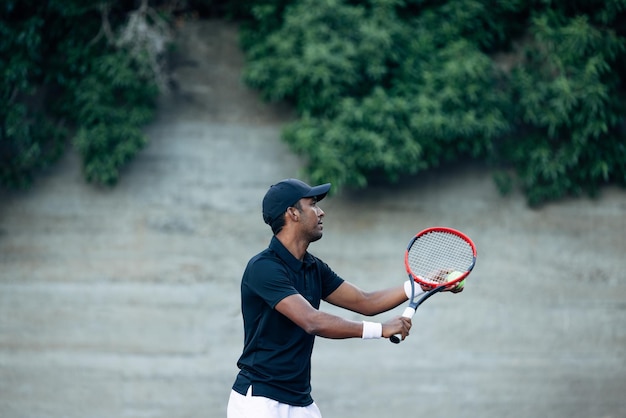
[[233, 237, 343, 406]]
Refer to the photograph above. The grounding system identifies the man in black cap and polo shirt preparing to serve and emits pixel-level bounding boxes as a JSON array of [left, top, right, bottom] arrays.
[[227, 179, 456, 418]]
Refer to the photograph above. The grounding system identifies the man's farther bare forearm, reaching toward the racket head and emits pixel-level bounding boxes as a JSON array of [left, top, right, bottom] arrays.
[[326, 282, 408, 316]]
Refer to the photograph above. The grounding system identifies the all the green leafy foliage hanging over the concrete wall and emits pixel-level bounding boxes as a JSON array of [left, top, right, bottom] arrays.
[[0, 0, 626, 205]]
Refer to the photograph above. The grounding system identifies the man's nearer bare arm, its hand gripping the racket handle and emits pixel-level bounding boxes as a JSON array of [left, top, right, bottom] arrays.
[[276, 290, 411, 339]]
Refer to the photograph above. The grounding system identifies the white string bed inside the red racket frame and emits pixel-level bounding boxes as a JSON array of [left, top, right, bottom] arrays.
[[407, 231, 474, 285]]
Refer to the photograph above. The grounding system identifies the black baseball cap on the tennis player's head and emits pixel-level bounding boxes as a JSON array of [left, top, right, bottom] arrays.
[[263, 179, 330, 225]]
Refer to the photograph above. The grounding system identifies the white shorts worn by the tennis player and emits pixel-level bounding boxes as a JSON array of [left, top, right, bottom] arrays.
[[226, 386, 322, 418]]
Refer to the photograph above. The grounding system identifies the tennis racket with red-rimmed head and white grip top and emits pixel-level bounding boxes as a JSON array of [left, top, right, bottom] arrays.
[[389, 227, 476, 344]]
